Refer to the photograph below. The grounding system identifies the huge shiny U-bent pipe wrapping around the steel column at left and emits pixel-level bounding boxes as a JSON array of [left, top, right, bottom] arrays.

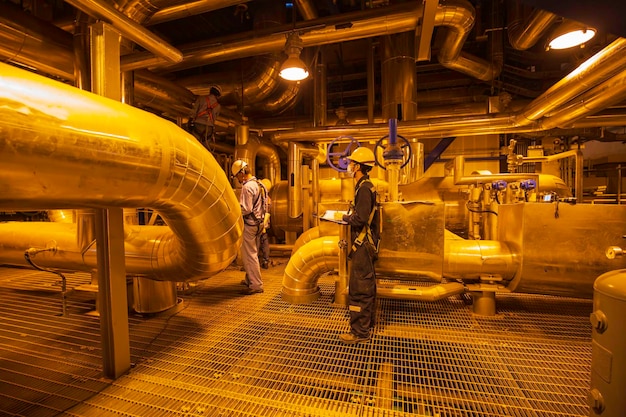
[[0, 64, 243, 281]]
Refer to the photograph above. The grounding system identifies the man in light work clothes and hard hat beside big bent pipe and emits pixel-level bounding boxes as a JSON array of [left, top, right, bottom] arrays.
[[230, 159, 267, 295]]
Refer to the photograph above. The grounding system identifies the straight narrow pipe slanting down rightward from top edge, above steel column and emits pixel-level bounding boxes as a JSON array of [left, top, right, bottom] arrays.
[[66, 0, 183, 62]]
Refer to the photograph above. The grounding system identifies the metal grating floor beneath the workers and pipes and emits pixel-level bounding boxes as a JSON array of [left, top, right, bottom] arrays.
[[0, 259, 592, 417]]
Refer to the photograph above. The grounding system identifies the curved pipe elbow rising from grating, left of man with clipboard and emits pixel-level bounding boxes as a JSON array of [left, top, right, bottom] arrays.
[[282, 236, 339, 304]]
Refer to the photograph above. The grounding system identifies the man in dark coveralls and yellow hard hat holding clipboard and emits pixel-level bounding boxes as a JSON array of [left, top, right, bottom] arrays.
[[339, 147, 380, 344]]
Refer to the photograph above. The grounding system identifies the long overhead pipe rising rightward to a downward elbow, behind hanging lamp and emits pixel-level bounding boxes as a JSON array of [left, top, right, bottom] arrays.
[[121, 0, 496, 86]]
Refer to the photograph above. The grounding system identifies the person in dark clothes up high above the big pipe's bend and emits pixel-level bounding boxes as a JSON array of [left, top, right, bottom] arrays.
[[188, 84, 222, 150]]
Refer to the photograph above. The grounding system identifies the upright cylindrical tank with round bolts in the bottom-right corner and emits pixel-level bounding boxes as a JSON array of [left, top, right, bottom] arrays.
[[588, 269, 626, 417]]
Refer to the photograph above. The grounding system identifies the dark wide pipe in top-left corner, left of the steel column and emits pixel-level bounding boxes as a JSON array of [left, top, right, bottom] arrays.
[[0, 2, 74, 81]]
